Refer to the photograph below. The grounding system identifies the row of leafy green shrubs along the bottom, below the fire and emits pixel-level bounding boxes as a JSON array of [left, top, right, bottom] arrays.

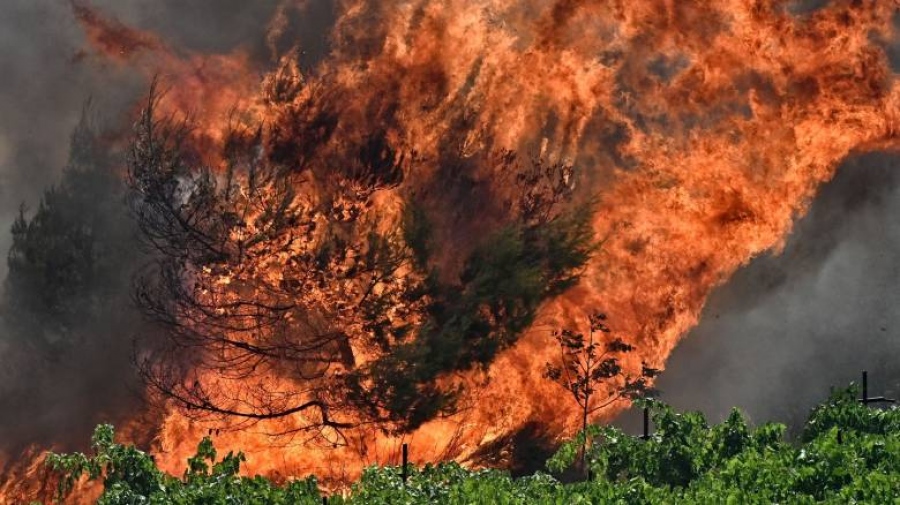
[[47, 389, 900, 505]]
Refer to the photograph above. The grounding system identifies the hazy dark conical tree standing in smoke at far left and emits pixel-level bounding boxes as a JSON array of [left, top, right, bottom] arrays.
[[0, 106, 134, 360]]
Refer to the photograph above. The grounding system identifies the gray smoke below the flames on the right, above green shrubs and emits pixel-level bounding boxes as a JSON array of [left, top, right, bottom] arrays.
[[620, 153, 900, 432]]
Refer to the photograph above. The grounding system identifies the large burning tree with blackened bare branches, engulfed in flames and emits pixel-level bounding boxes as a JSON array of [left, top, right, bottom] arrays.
[[129, 80, 594, 442]]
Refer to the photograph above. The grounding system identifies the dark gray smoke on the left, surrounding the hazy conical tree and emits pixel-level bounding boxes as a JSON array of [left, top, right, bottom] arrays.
[[0, 0, 334, 450]]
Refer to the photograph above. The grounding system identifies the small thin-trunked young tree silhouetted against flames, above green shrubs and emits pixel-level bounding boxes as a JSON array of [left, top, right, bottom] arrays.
[[544, 312, 659, 472]]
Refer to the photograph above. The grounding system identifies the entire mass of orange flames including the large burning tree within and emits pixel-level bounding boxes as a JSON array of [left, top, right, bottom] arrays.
[[4, 0, 900, 502]]
